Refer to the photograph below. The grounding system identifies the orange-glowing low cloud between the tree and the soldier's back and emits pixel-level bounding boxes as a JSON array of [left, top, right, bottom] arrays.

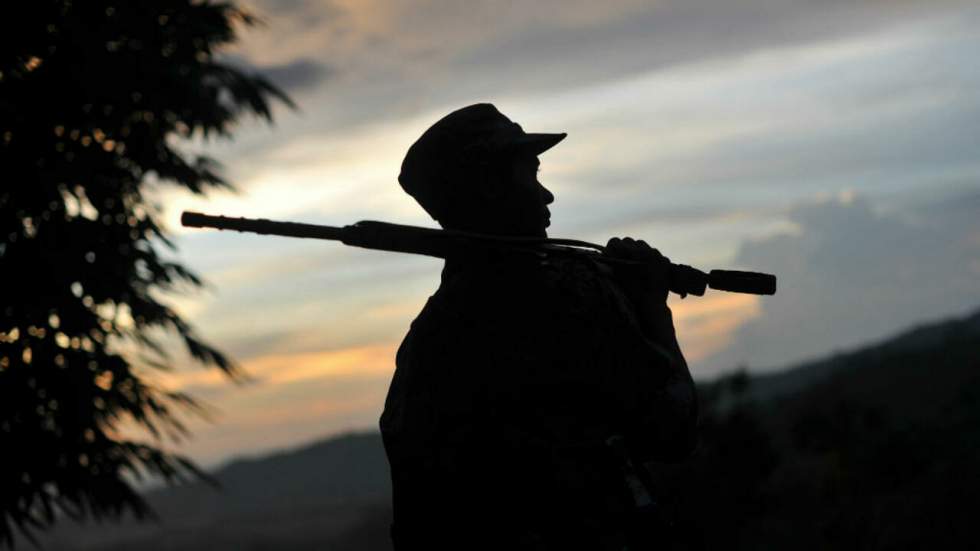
[[146, 341, 398, 465]]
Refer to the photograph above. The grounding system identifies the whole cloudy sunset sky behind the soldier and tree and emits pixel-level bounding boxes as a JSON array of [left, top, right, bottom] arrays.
[[147, 0, 980, 465]]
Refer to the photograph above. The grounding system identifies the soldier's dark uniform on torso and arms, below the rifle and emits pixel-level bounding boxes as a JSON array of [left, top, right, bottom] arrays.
[[381, 103, 696, 551]]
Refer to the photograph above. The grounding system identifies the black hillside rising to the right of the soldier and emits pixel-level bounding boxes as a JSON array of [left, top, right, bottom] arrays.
[[653, 312, 980, 550]]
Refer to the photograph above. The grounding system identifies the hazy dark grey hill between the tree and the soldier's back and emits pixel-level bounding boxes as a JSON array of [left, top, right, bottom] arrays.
[[43, 433, 391, 551]]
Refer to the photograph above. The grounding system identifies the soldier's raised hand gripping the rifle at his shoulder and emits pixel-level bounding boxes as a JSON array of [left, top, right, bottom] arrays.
[[606, 237, 670, 303]]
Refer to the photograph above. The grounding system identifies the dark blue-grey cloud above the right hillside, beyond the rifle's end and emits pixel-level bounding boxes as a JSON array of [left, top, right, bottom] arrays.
[[701, 190, 980, 372]]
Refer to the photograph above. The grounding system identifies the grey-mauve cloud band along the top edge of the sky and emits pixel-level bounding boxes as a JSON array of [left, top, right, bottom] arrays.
[[226, 0, 976, 133]]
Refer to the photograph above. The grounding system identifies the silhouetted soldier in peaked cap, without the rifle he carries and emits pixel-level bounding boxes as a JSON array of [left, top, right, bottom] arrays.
[[381, 104, 697, 550]]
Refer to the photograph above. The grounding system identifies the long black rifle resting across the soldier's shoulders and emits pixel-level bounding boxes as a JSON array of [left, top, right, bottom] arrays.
[[180, 211, 776, 298]]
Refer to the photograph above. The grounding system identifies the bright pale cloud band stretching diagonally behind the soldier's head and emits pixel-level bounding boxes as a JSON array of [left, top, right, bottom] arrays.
[[169, 12, 980, 382]]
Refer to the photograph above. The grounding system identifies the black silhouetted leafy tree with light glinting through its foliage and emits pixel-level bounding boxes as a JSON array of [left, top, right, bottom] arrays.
[[0, 0, 291, 545]]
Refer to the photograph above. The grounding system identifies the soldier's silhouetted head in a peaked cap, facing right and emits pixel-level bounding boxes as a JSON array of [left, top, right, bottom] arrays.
[[398, 103, 565, 237]]
